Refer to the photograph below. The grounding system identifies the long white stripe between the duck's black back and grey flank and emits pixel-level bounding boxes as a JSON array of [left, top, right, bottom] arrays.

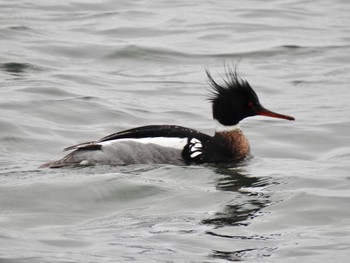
[[99, 137, 188, 150]]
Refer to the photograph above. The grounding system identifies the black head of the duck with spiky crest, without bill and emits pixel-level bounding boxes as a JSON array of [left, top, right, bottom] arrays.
[[206, 67, 261, 125]]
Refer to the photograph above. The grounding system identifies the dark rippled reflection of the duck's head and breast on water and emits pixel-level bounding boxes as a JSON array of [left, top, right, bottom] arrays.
[[202, 165, 277, 261]]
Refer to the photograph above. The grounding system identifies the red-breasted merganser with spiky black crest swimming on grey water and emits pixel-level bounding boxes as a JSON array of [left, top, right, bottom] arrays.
[[41, 67, 294, 168]]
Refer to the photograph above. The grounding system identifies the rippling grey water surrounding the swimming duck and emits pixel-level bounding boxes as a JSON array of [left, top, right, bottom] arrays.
[[0, 0, 350, 262]]
